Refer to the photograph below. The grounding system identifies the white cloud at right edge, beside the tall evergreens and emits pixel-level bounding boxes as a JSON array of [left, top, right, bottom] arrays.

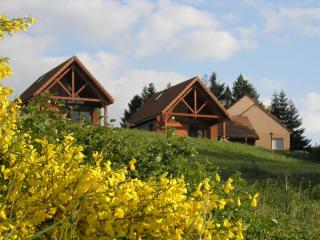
[[302, 92, 320, 134]]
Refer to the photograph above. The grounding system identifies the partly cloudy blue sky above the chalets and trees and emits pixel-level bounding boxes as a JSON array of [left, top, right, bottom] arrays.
[[0, 0, 320, 143]]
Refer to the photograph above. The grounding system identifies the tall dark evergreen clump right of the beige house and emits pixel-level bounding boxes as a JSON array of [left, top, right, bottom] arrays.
[[270, 90, 311, 150]]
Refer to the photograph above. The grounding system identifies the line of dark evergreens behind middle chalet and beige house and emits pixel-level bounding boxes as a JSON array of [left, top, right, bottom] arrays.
[[121, 72, 311, 150]]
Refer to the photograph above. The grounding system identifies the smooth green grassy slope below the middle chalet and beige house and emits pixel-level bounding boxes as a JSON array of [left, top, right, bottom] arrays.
[[122, 130, 320, 183]]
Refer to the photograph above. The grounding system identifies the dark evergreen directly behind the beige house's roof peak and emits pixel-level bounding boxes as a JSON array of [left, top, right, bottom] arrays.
[[232, 74, 259, 102]]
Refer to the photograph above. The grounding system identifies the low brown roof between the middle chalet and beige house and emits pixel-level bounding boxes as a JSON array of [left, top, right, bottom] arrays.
[[226, 116, 259, 139]]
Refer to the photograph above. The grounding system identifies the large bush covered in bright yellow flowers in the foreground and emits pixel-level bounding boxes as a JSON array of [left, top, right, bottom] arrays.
[[0, 14, 258, 240]]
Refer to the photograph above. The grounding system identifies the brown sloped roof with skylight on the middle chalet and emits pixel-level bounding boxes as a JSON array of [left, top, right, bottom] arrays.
[[128, 76, 230, 124]]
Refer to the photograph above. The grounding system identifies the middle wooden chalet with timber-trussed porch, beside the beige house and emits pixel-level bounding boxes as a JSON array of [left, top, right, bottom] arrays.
[[128, 77, 231, 139]]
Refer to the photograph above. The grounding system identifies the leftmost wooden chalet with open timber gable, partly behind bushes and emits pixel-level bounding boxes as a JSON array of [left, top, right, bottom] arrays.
[[20, 56, 114, 125]]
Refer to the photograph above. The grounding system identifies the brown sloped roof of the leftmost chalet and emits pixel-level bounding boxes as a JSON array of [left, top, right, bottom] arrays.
[[20, 56, 114, 103]]
